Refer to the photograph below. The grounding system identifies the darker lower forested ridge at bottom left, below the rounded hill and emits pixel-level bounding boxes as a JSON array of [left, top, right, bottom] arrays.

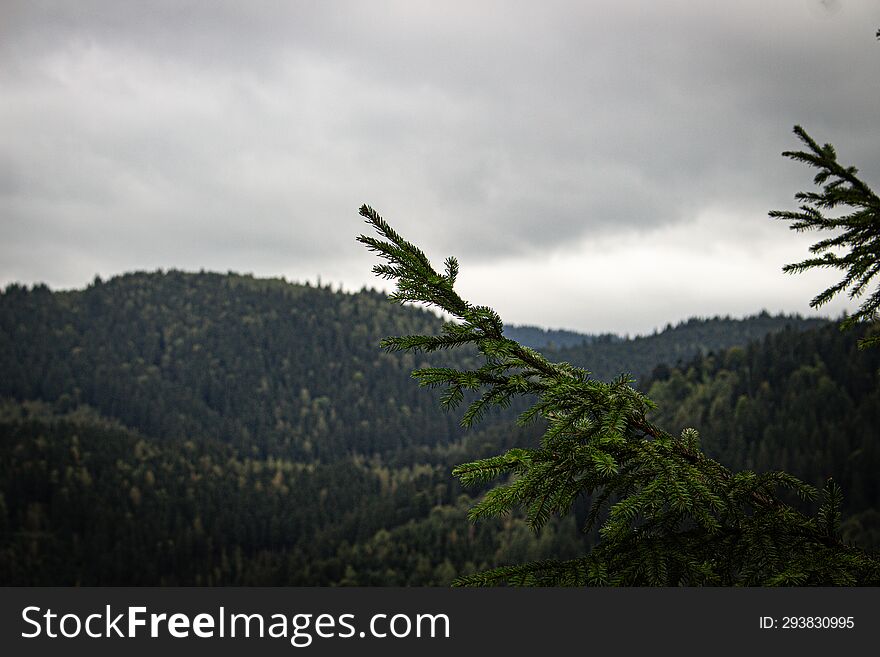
[[0, 402, 577, 586]]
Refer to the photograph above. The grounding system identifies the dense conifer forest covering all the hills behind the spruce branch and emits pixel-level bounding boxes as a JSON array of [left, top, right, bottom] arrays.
[[0, 271, 868, 586]]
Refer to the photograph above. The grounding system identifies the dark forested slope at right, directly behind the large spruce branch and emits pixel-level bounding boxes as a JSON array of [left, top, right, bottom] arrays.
[[643, 326, 880, 549]]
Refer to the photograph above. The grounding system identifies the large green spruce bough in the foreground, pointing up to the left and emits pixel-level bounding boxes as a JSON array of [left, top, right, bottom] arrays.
[[358, 206, 880, 586]]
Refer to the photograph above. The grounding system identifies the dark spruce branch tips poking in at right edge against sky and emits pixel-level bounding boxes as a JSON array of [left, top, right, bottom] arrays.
[[770, 126, 880, 347]]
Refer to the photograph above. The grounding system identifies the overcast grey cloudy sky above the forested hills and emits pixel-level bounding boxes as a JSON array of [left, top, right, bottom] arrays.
[[0, 0, 880, 334]]
